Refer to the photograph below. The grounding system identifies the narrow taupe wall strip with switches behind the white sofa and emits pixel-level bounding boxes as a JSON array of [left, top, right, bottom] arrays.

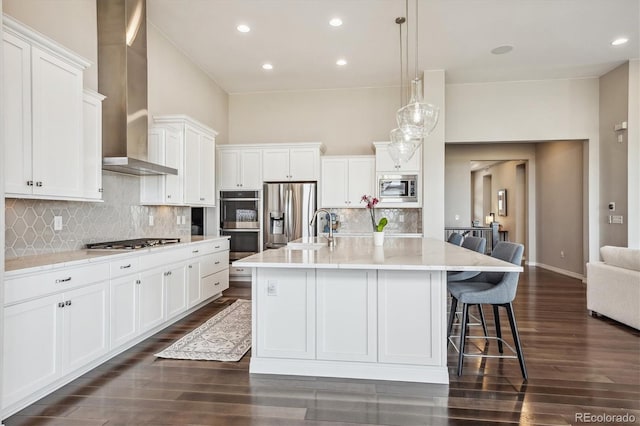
[[598, 64, 640, 246]]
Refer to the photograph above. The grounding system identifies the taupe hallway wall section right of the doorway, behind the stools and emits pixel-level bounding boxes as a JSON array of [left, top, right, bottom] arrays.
[[536, 141, 585, 275]]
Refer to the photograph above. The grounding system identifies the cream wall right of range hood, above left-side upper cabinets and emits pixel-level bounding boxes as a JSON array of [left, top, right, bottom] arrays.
[[147, 22, 229, 143]]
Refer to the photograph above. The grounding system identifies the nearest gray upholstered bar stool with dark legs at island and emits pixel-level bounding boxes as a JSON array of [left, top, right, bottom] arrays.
[[447, 241, 528, 380]]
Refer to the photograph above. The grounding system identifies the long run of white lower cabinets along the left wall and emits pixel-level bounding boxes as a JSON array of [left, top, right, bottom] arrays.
[[1, 239, 229, 416]]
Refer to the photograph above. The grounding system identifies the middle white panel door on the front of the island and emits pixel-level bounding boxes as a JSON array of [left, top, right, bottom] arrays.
[[316, 269, 377, 362]]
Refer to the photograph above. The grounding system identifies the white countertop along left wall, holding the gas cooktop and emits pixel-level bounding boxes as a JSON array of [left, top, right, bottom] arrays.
[[4, 236, 229, 277]]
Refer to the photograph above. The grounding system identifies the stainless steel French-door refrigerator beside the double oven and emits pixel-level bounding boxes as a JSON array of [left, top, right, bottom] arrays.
[[263, 182, 316, 250]]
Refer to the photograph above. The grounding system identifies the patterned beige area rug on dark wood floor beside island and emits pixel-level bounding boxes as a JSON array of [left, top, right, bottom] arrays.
[[155, 299, 251, 361]]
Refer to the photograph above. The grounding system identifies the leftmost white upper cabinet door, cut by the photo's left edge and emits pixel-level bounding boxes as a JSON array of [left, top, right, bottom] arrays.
[[2, 33, 32, 194]]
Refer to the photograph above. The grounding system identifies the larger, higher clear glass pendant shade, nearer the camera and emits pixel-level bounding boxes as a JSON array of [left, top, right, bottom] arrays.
[[396, 78, 440, 138]]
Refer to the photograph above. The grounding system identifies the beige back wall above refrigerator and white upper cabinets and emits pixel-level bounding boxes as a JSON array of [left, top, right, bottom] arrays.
[[229, 87, 400, 155]]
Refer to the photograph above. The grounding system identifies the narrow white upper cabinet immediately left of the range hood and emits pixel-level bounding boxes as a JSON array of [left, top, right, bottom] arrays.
[[82, 89, 105, 200]]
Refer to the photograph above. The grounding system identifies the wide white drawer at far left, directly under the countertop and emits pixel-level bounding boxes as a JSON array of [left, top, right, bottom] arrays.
[[4, 263, 109, 304]]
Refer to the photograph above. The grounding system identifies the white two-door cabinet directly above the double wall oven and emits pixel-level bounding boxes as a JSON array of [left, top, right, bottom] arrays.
[[216, 146, 262, 190]]
